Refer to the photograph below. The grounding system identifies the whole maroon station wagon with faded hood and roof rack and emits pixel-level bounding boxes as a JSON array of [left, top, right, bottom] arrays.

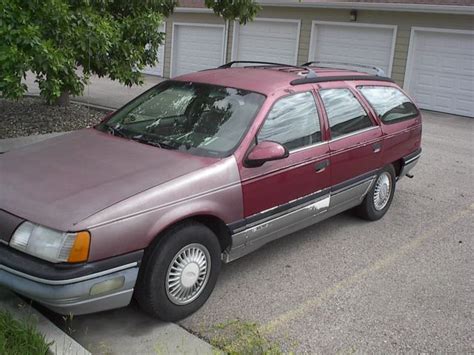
[[0, 62, 422, 320]]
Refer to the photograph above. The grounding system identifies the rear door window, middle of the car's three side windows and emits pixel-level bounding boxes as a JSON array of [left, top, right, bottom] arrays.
[[319, 89, 373, 138]]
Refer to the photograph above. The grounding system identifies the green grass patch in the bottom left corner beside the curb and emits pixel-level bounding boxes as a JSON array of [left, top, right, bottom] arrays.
[[0, 310, 49, 355]]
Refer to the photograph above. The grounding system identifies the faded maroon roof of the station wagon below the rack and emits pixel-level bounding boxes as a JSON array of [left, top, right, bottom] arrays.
[[173, 66, 390, 95]]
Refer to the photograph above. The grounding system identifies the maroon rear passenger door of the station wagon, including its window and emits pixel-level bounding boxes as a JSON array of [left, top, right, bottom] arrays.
[[318, 83, 383, 208]]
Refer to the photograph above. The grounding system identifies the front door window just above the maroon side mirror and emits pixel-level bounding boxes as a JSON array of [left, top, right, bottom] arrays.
[[257, 92, 321, 150]]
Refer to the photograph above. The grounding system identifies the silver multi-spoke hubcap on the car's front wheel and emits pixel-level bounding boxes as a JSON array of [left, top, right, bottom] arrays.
[[165, 243, 211, 305]]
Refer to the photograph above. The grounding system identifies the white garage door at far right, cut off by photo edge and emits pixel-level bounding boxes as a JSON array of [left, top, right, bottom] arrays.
[[405, 28, 474, 117]]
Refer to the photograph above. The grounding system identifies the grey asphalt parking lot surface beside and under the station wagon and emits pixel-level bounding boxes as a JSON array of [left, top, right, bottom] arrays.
[[39, 112, 474, 353]]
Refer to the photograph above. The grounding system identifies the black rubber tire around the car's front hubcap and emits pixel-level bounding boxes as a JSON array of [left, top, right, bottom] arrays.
[[135, 222, 221, 322]]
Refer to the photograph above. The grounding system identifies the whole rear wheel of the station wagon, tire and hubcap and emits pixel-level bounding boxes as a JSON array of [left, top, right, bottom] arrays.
[[356, 165, 395, 221]]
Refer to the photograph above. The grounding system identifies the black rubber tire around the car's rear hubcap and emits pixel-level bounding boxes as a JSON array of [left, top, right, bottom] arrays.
[[355, 165, 396, 221]]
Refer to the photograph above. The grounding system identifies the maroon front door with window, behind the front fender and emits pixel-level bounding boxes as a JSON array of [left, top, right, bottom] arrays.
[[241, 91, 330, 227]]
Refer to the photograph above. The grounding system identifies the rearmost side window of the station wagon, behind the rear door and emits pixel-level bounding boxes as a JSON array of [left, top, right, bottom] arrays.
[[358, 86, 418, 123]]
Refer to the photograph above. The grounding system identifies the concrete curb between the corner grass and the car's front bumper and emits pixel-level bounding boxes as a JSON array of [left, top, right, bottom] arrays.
[[0, 287, 90, 355]]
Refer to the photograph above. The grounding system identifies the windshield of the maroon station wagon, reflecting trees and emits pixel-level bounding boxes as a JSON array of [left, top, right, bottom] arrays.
[[96, 81, 265, 157]]
